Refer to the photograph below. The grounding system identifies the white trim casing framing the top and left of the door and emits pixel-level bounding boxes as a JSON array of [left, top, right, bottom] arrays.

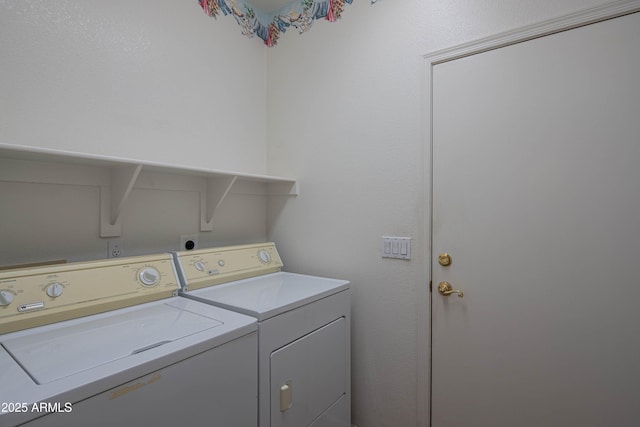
[[417, 0, 640, 427]]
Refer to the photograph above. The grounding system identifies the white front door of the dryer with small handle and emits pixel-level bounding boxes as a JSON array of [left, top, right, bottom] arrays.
[[271, 318, 349, 427]]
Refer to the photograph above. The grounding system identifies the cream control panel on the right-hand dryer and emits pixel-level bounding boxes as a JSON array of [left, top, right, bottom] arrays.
[[175, 243, 282, 291]]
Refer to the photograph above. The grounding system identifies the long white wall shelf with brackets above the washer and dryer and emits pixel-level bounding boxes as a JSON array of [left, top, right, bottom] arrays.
[[0, 143, 298, 237]]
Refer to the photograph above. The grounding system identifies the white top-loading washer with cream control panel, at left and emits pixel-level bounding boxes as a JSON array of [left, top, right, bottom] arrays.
[[0, 254, 258, 427]]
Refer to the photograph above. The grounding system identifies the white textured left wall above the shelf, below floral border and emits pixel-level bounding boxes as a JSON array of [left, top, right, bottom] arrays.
[[0, 0, 266, 173]]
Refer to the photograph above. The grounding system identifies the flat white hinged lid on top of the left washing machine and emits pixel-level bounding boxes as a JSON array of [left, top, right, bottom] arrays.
[[2, 303, 223, 384]]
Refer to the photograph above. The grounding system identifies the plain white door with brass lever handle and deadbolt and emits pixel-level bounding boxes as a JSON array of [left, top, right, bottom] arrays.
[[431, 13, 640, 427]]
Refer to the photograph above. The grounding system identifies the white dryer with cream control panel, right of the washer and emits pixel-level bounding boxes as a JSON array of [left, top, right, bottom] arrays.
[[174, 243, 351, 427]]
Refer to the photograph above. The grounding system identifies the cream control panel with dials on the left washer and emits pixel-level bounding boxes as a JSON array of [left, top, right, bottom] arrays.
[[0, 254, 180, 334]]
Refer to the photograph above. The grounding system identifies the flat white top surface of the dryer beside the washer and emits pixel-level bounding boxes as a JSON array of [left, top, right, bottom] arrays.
[[186, 272, 349, 320]]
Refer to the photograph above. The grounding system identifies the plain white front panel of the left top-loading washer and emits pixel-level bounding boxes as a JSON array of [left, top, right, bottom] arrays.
[[27, 332, 258, 427]]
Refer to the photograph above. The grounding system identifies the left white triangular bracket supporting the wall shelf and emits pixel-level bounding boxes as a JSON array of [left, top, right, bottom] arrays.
[[100, 165, 142, 237]]
